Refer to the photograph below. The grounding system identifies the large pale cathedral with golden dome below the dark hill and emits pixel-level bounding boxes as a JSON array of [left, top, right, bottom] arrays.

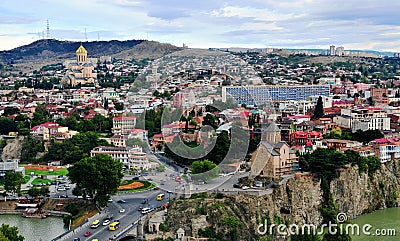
[[61, 44, 97, 87]]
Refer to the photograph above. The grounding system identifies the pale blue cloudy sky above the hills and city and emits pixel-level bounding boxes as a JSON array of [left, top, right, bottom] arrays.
[[0, 0, 400, 52]]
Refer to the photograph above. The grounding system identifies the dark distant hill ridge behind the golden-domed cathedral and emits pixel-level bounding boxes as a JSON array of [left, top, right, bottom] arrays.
[[0, 39, 181, 65]]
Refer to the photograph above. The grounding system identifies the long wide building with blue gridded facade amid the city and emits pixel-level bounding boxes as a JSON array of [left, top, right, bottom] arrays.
[[222, 85, 330, 105]]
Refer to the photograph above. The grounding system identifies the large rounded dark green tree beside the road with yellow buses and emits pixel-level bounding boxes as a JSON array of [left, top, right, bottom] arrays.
[[68, 154, 123, 207]]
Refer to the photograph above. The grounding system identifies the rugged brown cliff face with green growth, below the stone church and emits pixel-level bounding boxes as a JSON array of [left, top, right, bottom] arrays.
[[166, 160, 400, 240]]
